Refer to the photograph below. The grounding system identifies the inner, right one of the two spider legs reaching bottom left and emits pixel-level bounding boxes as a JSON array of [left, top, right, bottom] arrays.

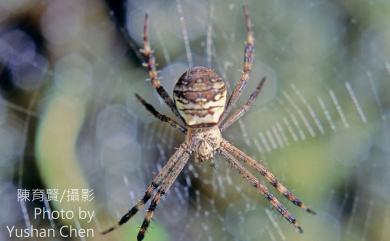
[[137, 148, 190, 241]]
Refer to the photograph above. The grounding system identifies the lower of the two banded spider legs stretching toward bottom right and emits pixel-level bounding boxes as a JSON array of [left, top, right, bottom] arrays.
[[219, 147, 303, 233]]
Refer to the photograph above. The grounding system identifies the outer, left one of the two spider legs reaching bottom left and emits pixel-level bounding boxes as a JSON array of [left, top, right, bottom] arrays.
[[101, 144, 187, 234]]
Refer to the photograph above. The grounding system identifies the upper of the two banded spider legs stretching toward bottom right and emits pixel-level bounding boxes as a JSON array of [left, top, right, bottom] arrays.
[[221, 140, 316, 214]]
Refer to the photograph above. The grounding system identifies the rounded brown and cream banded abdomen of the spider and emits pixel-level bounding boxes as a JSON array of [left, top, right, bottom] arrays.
[[173, 66, 226, 127]]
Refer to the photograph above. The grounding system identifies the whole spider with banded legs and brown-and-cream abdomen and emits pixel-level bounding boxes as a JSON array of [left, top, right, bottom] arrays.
[[102, 5, 315, 241]]
